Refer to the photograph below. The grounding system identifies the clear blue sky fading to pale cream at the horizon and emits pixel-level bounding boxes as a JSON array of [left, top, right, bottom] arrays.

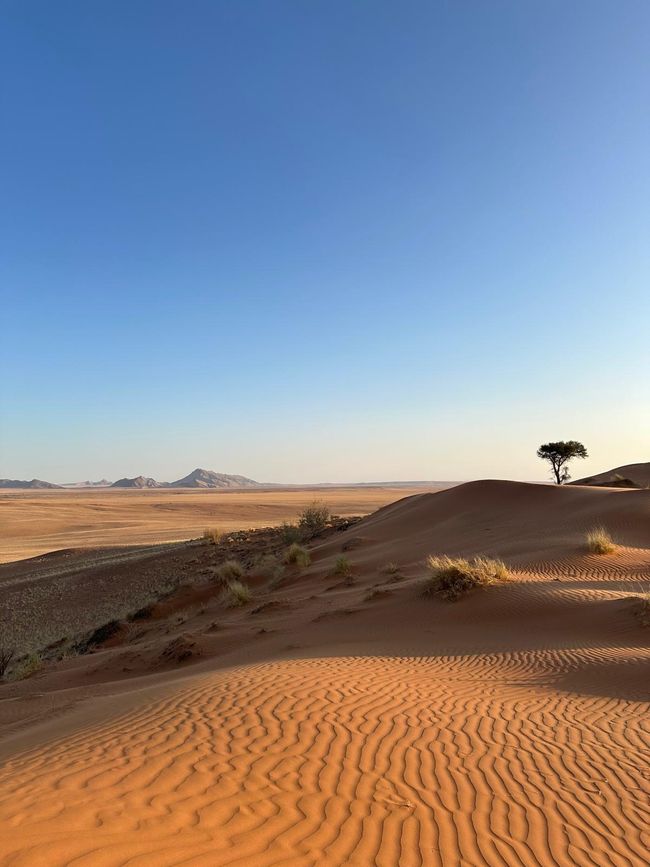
[[0, 0, 650, 482]]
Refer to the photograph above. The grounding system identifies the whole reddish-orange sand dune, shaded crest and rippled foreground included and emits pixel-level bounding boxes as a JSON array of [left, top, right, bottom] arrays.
[[0, 482, 650, 867]]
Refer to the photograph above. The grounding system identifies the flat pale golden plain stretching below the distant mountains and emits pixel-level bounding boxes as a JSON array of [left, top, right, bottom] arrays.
[[0, 486, 435, 563]]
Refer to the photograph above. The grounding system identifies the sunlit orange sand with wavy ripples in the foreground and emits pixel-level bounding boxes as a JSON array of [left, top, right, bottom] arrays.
[[0, 651, 650, 867]]
